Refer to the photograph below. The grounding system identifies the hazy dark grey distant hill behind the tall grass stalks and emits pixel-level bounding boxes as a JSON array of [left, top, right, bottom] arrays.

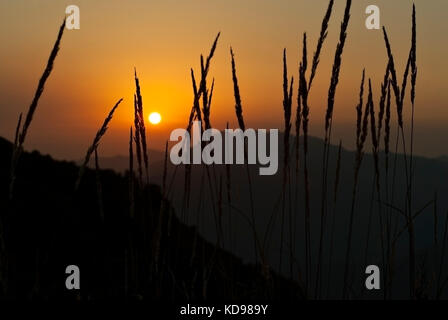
[[136, 133, 448, 298]]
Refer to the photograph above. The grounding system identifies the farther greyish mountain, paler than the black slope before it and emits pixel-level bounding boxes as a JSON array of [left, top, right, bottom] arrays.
[[147, 133, 448, 299]]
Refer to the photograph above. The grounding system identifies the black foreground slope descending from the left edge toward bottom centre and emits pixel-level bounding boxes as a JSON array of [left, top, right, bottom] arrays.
[[0, 138, 302, 300]]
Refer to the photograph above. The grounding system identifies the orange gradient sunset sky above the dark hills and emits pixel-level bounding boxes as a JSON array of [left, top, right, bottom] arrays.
[[0, 0, 448, 159]]
